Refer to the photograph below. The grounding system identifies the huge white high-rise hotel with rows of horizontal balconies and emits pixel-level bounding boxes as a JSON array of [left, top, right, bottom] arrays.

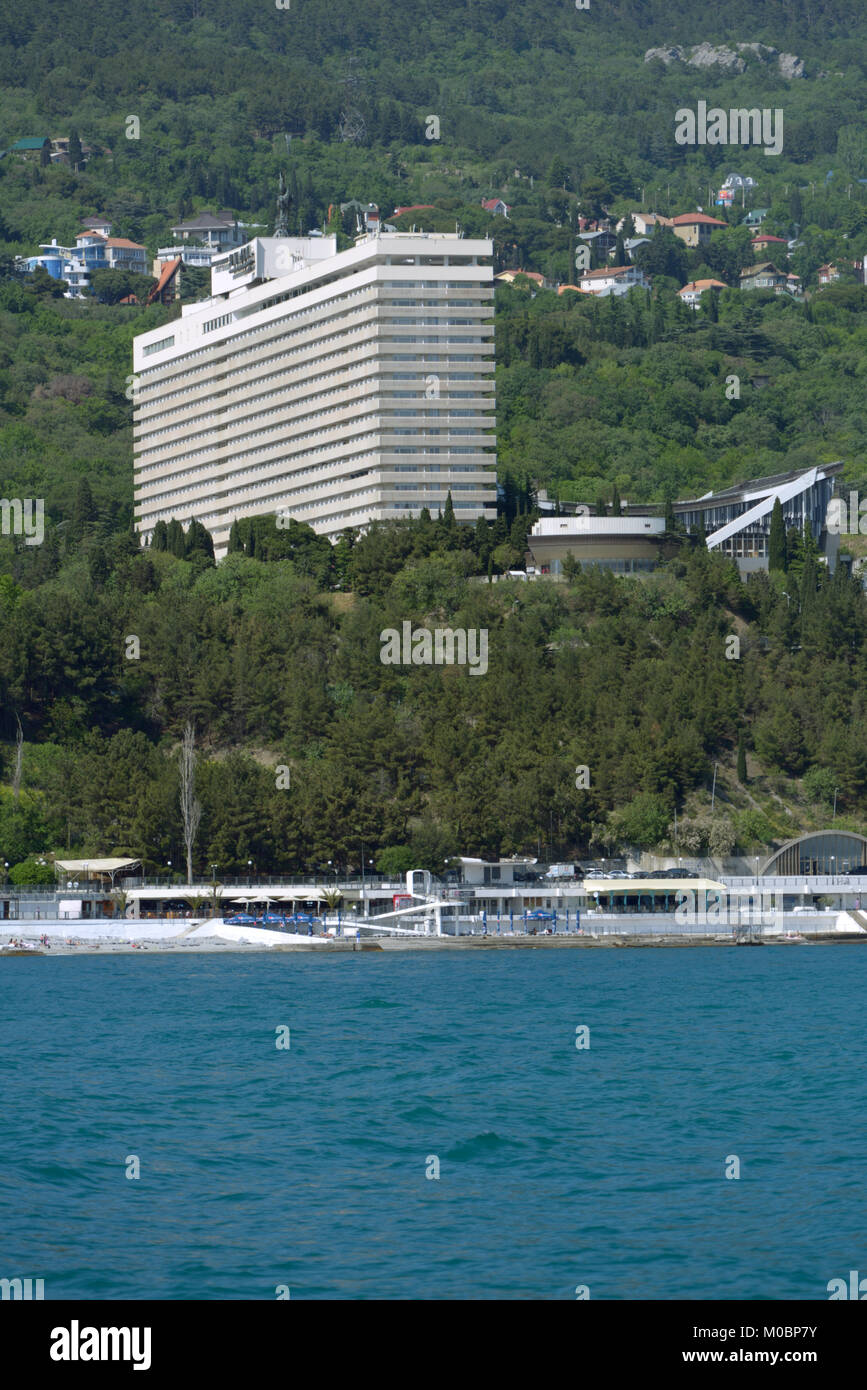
[[133, 232, 496, 555]]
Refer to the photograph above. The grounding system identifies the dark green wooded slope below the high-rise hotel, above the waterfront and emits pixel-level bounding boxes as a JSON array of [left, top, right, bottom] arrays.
[[0, 503, 867, 873]]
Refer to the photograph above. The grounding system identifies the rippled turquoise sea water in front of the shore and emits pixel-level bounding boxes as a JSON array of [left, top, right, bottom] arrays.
[[0, 945, 867, 1300]]
